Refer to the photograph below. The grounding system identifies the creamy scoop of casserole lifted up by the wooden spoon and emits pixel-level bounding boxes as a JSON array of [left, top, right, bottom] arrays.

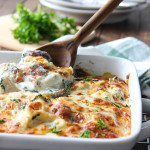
[[0, 53, 73, 93]]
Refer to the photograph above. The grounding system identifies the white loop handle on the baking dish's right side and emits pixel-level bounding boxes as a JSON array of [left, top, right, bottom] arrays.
[[138, 98, 150, 142]]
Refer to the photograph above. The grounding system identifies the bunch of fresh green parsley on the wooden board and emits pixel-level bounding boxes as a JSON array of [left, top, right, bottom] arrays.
[[12, 3, 77, 43]]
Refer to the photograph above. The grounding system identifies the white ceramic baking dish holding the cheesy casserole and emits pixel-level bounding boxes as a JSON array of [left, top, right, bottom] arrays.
[[0, 51, 150, 150]]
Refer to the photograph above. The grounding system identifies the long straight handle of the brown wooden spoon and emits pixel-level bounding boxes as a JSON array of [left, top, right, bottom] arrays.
[[73, 0, 123, 45]]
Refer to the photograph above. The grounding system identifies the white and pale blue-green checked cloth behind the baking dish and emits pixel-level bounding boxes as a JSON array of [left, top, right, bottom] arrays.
[[55, 35, 150, 98]]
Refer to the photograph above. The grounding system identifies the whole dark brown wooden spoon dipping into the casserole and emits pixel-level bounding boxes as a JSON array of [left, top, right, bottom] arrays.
[[36, 0, 122, 67]]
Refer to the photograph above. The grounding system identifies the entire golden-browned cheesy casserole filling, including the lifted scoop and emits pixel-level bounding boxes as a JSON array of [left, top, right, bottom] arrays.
[[0, 50, 131, 138]]
